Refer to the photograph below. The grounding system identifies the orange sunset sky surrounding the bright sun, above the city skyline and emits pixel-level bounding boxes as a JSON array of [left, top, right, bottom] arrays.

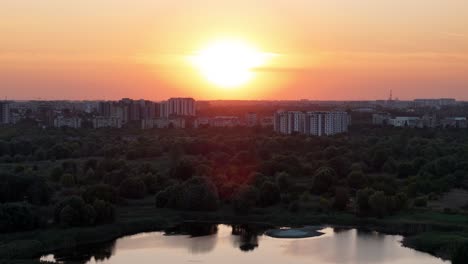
[[0, 0, 468, 100]]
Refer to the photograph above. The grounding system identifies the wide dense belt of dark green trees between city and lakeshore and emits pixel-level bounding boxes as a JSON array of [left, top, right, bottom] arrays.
[[0, 127, 468, 262]]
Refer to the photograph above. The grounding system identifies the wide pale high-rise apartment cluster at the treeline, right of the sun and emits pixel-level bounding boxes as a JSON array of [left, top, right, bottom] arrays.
[[274, 111, 349, 136]]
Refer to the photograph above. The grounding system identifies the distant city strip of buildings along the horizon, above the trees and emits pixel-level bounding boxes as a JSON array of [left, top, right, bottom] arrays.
[[0, 96, 468, 136]]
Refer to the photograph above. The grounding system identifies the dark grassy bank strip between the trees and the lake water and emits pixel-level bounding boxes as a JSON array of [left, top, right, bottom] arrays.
[[0, 206, 468, 263]]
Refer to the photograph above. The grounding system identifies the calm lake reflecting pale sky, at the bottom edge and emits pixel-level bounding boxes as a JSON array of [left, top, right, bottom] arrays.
[[42, 223, 450, 264]]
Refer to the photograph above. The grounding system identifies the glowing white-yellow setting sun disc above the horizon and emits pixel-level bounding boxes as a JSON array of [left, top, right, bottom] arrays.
[[190, 40, 274, 88]]
